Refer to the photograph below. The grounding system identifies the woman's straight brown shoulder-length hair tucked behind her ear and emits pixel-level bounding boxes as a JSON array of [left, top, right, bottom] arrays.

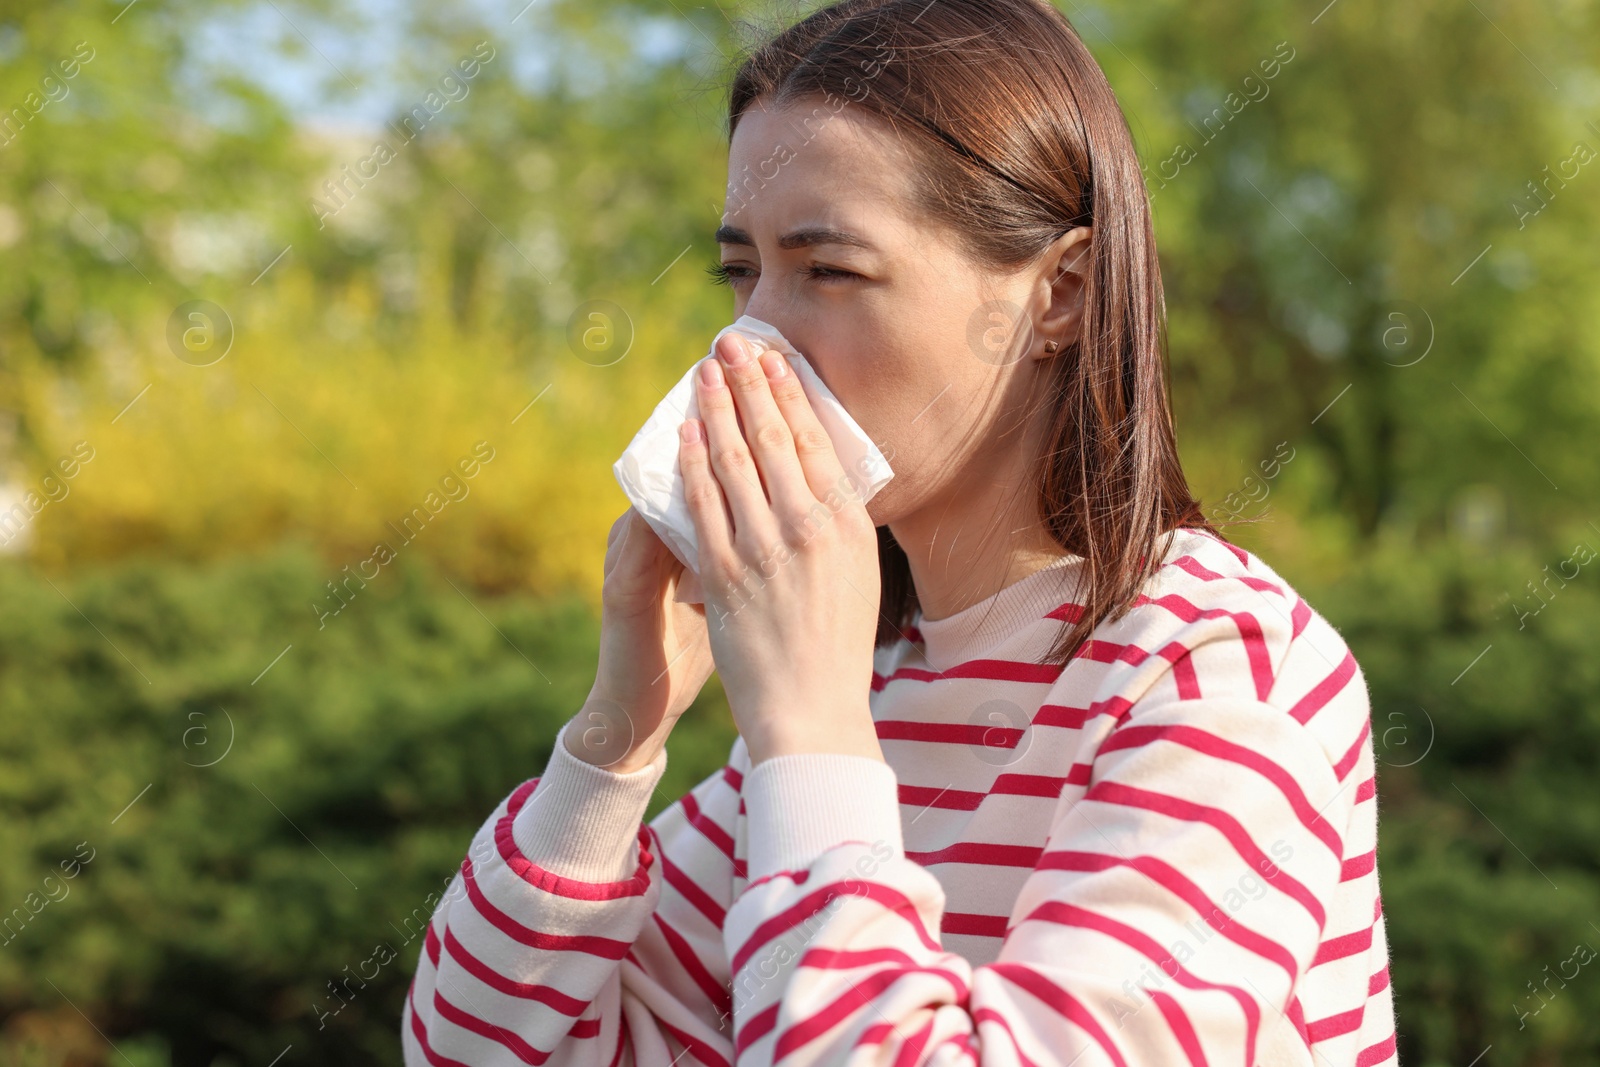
[[728, 0, 1216, 665]]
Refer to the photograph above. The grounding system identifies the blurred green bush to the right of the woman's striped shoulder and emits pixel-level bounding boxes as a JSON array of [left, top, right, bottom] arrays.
[[1301, 528, 1600, 1067]]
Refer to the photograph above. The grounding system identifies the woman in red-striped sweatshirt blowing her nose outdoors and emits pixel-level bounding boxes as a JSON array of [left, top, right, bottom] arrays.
[[402, 0, 1395, 1067]]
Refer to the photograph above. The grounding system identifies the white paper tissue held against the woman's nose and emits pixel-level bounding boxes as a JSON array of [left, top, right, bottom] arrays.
[[611, 315, 894, 603]]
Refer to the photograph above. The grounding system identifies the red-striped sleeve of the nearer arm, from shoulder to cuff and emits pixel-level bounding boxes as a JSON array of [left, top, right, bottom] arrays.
[[725, 659, 1354, 1067]]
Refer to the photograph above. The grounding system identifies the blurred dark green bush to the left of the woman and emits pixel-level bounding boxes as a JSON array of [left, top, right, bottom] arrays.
[[0, 547, 733, 1067]]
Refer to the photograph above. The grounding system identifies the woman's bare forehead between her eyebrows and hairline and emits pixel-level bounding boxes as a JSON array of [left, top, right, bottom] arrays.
[[725, 96, 910, 232]]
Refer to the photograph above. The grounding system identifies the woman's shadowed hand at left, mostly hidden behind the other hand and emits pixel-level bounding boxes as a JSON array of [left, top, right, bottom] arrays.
[[566, 507, 714, 774]]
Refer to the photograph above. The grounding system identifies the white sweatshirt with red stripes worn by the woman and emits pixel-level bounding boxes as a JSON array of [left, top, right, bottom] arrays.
[[402, 528, 1397, 1067]]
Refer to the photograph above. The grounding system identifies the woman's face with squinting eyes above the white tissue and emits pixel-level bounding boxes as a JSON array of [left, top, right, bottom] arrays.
[[718, 96, 1050, 526]]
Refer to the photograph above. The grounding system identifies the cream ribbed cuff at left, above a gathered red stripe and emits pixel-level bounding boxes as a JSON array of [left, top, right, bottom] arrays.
[[510, 720, 667, 883]]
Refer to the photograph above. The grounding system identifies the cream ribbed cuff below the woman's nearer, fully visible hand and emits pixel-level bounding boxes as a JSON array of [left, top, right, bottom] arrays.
[[742, 752, 904, 881]]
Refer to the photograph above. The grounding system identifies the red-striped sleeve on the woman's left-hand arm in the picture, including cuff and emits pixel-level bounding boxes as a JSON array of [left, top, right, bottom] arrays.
[[402, 723, 739, 1067]]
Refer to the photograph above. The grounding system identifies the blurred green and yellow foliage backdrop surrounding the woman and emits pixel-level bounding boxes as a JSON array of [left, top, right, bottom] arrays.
[[0, 0, 1600, 1067]]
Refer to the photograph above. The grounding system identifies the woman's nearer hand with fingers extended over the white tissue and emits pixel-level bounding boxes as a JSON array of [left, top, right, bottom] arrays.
[[678, 334, 883, 763]]
